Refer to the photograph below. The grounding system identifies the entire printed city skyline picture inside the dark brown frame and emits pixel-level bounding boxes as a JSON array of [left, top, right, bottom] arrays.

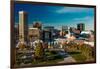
[[11, 2, 96, 68]]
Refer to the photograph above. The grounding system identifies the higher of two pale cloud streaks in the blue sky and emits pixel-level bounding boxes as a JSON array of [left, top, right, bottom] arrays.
[[56, 7, 90, 13]]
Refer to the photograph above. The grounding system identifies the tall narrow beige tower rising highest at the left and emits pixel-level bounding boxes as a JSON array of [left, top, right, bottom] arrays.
[[19, 11, 28, 43]]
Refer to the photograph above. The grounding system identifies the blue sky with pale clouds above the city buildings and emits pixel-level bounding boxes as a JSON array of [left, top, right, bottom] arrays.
[[14, 3, 94, 30]]
